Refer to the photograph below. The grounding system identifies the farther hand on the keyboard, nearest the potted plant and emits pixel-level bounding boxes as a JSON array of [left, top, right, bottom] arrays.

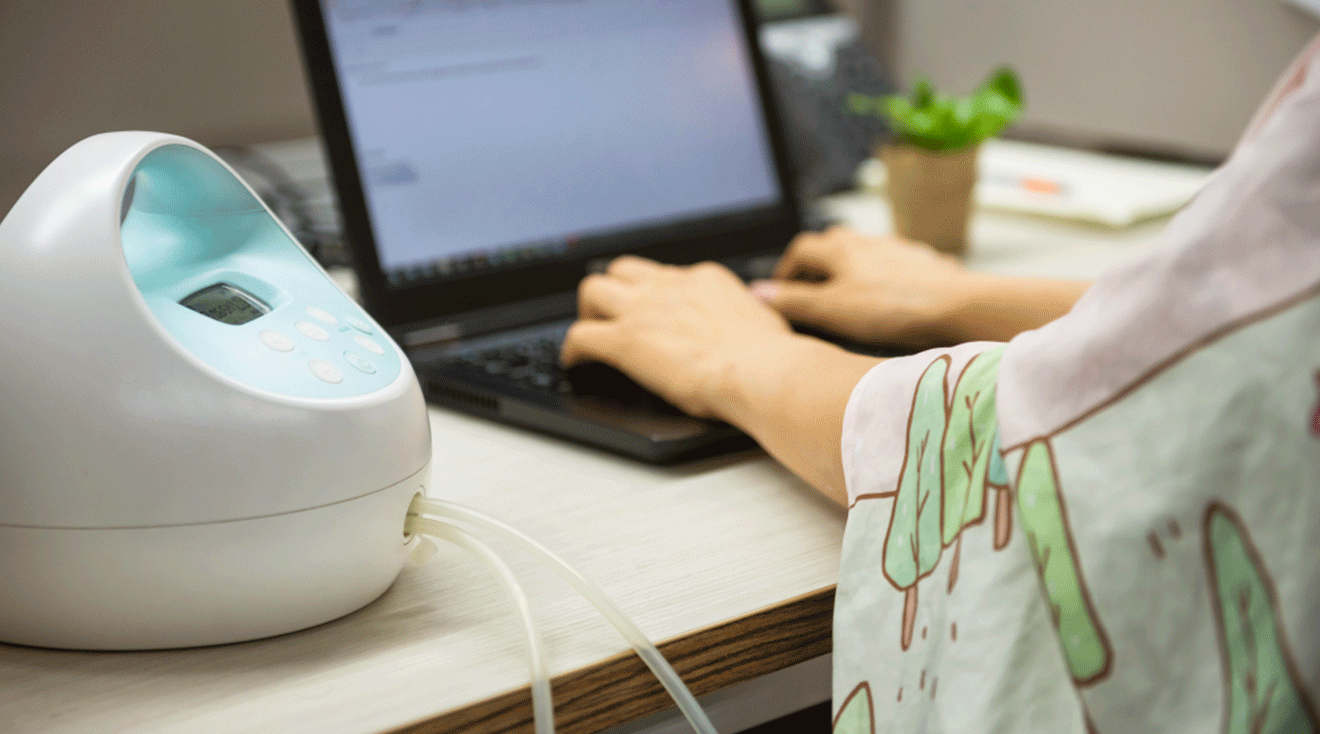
[[752, 227, 974, 347]]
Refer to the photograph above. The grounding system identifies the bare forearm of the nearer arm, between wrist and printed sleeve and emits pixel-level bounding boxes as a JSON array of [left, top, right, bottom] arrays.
[[711, 335, 880, 507]]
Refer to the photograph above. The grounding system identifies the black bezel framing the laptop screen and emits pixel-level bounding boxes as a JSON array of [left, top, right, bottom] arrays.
[[292, 0, 801, 329]]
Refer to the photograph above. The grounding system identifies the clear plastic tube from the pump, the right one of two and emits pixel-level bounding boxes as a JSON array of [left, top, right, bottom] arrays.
[[408, 495, 717, 734]]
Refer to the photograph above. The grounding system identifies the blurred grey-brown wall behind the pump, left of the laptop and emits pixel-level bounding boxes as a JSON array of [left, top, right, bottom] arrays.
[[0, 0, 314, 209]]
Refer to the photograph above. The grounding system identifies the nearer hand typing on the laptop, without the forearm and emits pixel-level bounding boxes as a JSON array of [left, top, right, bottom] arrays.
[[562, 256, 793, 420]]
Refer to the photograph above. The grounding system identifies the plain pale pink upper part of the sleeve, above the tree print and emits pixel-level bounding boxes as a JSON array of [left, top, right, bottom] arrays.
[[998, 44, 1320, 449]]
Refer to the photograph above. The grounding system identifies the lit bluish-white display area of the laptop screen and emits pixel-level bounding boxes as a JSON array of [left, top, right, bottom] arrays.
[[325, 0, 781, 280]]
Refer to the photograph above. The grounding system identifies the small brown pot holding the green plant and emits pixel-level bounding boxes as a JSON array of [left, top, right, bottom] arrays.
[[879, 145, 977, 256]]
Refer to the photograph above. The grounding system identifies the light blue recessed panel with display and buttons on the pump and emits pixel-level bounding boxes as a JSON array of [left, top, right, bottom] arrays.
[[120, 145, 401, 399]]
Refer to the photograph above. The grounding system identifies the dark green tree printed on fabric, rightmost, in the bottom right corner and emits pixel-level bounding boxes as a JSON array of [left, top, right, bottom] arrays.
[[1204, 503, 1320, 734]]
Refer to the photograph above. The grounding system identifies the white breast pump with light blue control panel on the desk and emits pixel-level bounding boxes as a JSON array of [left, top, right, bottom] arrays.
[[0, 132, 430, 650]]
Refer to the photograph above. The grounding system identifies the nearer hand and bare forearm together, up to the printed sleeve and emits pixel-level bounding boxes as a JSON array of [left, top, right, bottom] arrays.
[[562, 256, 879, 504]]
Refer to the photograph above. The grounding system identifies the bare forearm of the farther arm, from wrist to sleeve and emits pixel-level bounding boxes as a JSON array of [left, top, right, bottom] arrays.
[[944, 273, 1090, 343]]
